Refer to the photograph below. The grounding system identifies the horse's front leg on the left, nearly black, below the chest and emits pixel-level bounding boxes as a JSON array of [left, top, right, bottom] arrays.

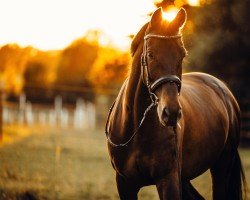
[[116, 174, 140, 200]]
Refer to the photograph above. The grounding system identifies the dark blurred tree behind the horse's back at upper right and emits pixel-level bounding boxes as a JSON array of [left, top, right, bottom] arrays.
[[188, 0, 250, 100]]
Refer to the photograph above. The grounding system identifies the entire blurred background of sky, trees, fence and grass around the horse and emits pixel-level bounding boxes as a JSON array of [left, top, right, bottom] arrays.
[[0, 0, 250, 199]]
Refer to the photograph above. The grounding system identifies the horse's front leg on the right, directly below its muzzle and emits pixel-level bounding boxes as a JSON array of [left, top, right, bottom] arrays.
[[156, 170, 182, 200]]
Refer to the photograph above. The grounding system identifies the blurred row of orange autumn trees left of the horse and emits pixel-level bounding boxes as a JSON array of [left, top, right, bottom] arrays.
[[0, 30, 130, 103]]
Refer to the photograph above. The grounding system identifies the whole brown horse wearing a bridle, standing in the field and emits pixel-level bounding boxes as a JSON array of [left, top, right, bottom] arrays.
[[106, 9, 245, 200]]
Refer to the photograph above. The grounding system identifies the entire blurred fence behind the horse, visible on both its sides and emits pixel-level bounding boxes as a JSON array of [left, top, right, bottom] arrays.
[[0, 94, 250, 139]]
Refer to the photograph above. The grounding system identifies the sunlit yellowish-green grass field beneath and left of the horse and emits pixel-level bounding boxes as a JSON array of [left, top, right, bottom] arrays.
[[0, 127, 250, 200]]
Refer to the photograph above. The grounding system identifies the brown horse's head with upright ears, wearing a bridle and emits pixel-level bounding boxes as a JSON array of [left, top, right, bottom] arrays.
[[142, 8, 186, 126]]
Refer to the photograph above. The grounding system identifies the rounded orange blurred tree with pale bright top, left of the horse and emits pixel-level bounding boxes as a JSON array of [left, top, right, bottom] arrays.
[[56, 31, 99, 87]]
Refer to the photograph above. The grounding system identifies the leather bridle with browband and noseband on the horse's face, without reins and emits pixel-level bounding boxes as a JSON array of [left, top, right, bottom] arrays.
[[141, 34, 181, 104]]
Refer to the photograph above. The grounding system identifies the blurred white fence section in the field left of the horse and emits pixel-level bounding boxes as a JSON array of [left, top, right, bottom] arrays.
[[2, 94, 96, 129]]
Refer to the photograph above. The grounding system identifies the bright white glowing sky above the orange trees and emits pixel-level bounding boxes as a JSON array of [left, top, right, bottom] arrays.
[[0, 0, 155, 50]]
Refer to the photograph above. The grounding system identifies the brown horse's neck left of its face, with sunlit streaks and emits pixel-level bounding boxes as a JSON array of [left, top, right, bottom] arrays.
[[110, 54, 150, 140]]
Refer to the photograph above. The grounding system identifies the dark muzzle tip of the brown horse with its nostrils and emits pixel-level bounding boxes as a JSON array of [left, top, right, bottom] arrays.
[[160, 107, 181, 127]]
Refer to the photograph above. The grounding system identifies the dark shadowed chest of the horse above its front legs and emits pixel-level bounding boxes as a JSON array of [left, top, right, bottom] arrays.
[[110, 134, 176, 179]]
